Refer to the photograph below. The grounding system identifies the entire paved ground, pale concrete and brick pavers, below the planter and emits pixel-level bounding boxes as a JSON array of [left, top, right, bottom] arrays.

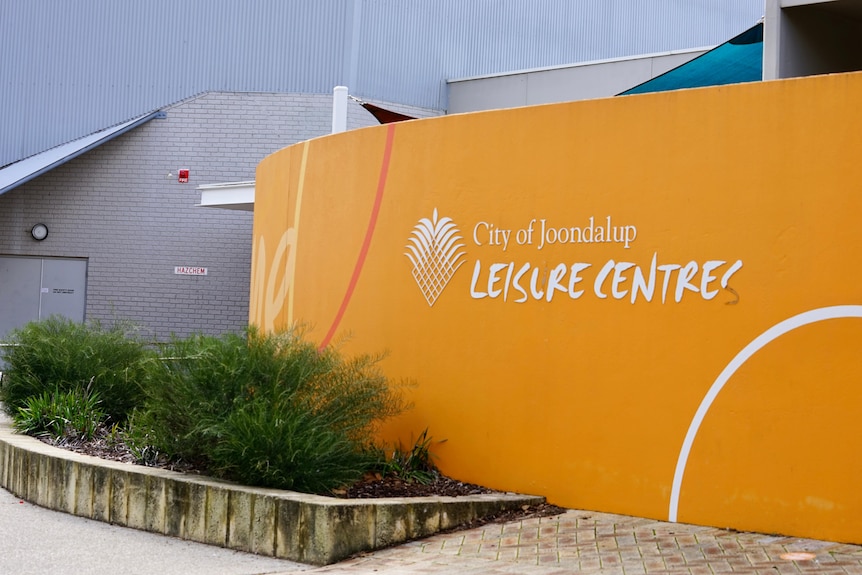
[[0, 484, 862, 575]]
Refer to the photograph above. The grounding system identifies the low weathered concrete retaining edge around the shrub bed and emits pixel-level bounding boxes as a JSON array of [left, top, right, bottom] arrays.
[[0, 418, 544, 565]]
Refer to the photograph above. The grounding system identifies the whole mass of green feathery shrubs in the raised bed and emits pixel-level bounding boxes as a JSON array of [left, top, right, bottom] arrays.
[[0, 317, 412, 493]]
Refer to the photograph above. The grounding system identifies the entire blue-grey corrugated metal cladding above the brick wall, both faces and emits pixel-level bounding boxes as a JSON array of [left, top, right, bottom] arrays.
[[5, 0, 763, 166]]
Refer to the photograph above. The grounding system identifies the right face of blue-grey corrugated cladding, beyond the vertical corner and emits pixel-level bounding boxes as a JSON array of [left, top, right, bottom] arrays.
[[354, 0, 763, 109]]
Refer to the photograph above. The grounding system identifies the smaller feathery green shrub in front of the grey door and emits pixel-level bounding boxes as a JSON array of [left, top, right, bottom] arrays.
[[0, 316, 150, 422]]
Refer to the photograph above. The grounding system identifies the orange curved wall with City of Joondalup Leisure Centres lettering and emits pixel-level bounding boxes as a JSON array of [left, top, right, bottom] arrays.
[[250, 74, 862, 543]]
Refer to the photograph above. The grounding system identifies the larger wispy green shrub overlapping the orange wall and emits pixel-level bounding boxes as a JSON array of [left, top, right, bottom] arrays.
[[129, 329, 404, 493]]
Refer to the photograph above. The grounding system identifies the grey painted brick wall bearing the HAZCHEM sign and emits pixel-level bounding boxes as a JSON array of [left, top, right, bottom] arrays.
[[0, 92, 442, 340]]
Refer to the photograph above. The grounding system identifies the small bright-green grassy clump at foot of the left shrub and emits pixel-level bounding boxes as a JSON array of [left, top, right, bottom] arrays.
[[13, 390, 105, 441]]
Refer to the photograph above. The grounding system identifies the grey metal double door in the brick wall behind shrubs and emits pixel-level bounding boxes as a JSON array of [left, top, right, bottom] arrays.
[[0, 256, 87, 339]]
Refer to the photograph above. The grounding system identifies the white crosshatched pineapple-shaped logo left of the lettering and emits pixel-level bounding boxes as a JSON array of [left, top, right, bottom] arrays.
[[404, 208, 464, 306]]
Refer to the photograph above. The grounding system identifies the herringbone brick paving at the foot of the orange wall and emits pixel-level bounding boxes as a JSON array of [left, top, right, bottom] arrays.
[[287, 510, 862, 575]]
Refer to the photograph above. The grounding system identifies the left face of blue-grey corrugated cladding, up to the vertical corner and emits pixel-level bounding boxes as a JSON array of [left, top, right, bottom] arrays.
[[0, 0, 346, 165]]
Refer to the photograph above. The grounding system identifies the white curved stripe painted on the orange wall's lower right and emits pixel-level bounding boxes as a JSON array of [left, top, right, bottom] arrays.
[[667, 305, 862, 522]]
